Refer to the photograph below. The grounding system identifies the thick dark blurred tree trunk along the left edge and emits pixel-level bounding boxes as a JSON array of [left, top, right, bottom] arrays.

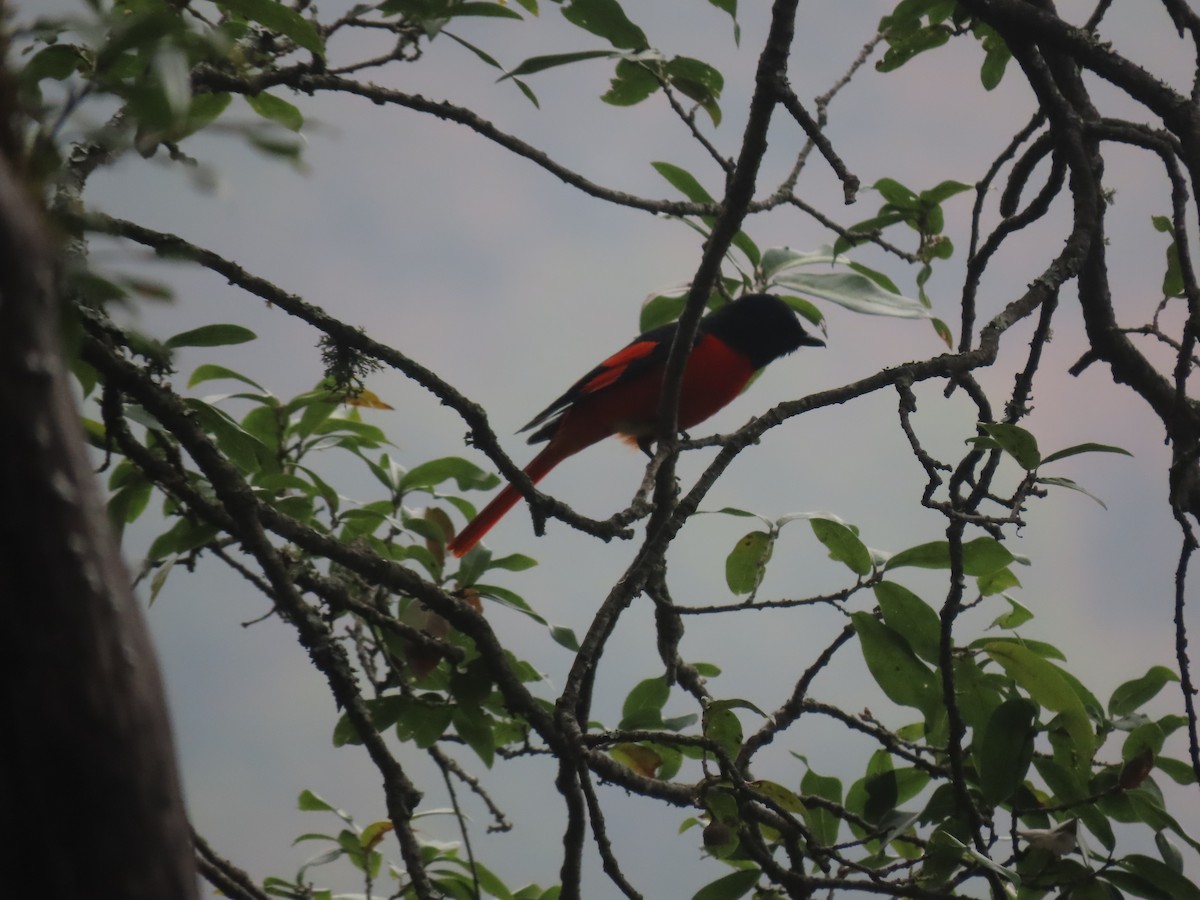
[[0, 28, 198, 900]]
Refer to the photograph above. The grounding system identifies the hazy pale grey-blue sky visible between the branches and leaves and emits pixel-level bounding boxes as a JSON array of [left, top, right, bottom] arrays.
[[17, 0, 1200, 896]]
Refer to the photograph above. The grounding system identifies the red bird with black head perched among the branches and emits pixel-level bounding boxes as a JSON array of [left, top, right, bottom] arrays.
[[449, 294, 824, 557]]
